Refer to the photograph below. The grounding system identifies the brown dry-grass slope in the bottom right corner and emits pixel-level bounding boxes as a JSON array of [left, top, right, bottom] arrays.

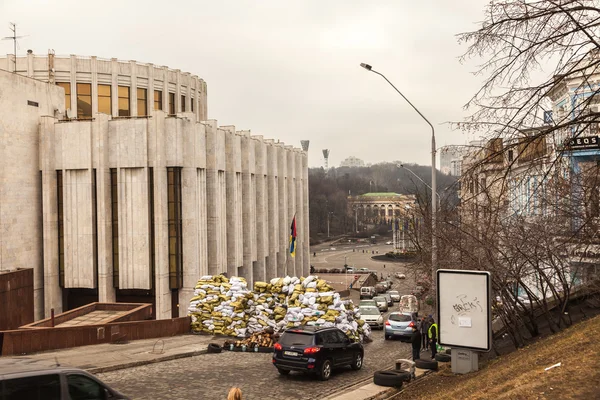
[[393, 316, 600, 400]]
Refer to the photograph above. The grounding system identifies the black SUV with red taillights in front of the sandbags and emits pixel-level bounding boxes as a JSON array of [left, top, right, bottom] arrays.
[[273, 326, 364, 381]]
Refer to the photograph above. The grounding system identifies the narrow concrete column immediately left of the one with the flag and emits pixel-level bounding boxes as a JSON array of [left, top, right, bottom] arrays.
[[275, 143, 291, 276]]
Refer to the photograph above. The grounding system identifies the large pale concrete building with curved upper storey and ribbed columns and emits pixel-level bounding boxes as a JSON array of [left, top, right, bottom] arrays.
[[0, 54, 310, 319]]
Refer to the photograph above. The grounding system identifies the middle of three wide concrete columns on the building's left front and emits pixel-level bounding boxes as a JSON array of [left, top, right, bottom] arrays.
[[92, 114, 116, 303]]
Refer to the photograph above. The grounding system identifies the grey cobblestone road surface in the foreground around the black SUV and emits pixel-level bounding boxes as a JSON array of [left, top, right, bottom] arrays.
[[98, 331, 411, 400]]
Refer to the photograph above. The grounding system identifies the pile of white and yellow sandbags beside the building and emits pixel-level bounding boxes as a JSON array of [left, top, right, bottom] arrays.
[[189, 276, 371, 341]]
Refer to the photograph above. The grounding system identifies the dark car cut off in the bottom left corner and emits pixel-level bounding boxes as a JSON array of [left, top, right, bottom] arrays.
[[0, 364, 129, 400]]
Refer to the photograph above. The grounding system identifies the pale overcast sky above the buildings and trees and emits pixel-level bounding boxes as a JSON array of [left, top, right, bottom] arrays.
[[0, 0, 486, 167]]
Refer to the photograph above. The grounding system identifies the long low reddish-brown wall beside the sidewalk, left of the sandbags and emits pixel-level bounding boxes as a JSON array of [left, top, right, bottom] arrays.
[[0, 317, 191, 356]]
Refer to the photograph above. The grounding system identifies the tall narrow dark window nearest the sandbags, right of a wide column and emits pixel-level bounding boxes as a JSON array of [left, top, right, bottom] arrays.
[[167, 167, 183, 289]]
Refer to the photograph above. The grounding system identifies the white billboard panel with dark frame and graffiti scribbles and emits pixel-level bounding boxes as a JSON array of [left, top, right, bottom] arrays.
[[437, 269, 492, 351]]
